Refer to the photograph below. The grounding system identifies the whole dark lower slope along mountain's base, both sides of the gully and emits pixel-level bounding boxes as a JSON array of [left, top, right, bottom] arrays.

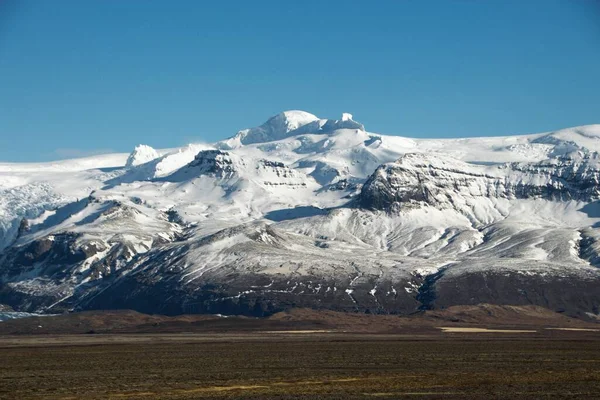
[[65, 262, 600, 317]]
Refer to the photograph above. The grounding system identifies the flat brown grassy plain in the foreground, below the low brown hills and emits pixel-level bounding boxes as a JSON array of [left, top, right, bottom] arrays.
[[0, 333, 600, 399]]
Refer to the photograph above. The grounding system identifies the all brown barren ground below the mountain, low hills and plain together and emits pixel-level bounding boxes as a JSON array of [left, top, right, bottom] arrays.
[[0, 305, 600, 399]]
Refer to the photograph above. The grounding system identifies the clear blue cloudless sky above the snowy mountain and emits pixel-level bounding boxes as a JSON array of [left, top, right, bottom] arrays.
[[0, 0, 600, 161]]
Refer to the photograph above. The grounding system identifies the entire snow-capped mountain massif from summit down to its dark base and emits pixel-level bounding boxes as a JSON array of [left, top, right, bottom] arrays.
[[0, 111, 600, 317]]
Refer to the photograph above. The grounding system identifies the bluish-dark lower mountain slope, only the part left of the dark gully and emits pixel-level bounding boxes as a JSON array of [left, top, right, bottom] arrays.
[[80, 274, 420, 317]]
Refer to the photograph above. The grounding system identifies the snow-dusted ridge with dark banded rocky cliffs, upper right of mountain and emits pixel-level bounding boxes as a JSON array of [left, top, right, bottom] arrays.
[[360, 152, 600, 219]]
